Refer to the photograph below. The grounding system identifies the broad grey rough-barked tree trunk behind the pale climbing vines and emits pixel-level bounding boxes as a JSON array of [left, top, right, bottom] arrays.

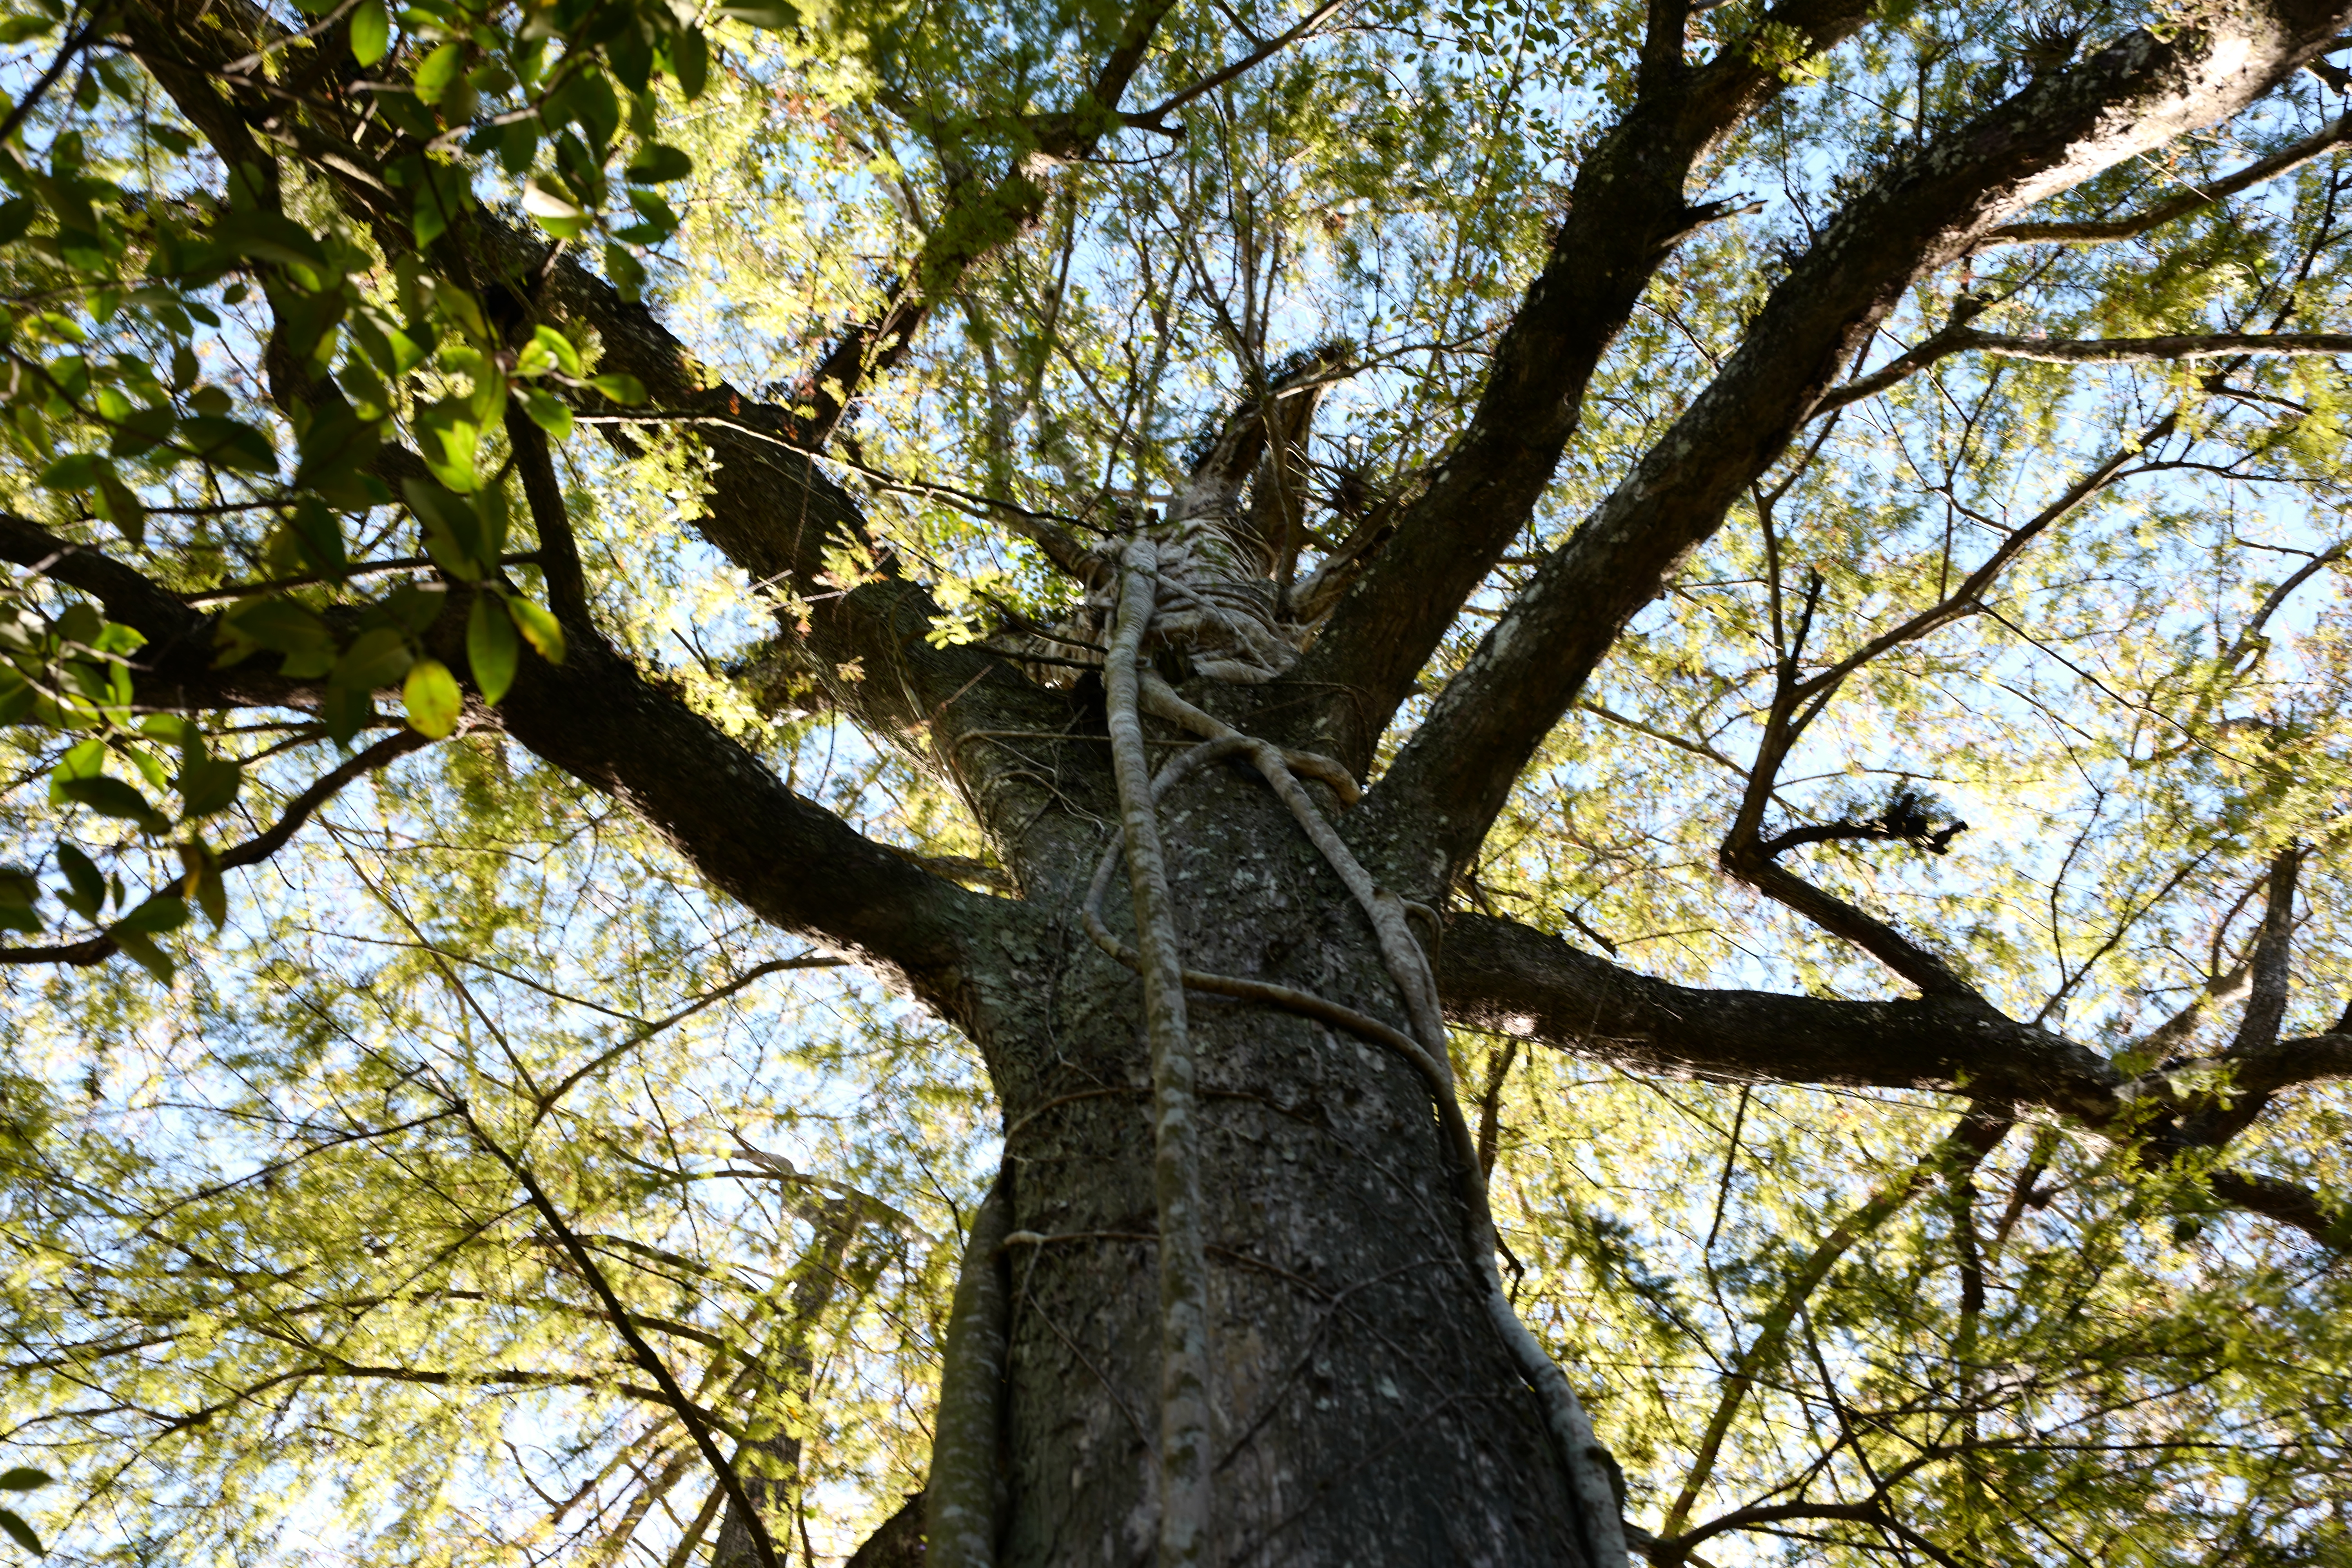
[[990, 766, 1588, 1568]]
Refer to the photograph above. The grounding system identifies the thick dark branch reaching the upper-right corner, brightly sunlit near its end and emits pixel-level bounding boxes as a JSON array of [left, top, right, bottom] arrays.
[[1376, 0, 2340, 867]]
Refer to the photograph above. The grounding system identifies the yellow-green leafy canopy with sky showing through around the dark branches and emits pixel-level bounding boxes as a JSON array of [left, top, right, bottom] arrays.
[[0, 0, 2352, 1566]]
